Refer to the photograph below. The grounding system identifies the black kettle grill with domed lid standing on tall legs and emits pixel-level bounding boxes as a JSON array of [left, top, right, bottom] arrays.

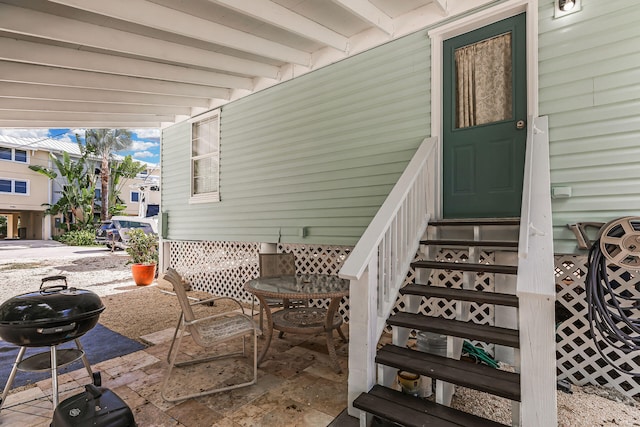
[[0, 276, 105, 409]]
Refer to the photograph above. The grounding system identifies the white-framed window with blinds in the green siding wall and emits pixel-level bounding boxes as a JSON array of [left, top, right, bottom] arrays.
[[191, 110, 220, 203]]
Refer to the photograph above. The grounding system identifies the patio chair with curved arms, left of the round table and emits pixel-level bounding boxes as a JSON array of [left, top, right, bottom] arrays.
[[158, 268, 258, 402]]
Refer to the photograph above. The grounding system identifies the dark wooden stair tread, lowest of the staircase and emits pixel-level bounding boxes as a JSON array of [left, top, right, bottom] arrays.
[[353, 385, 504, 427]]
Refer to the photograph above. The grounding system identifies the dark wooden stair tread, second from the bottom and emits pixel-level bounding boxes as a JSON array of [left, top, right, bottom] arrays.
[[376, 344, 520, 401]]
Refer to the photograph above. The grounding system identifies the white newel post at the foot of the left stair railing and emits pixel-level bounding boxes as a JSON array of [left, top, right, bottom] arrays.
[[348, 255, 378, 426]]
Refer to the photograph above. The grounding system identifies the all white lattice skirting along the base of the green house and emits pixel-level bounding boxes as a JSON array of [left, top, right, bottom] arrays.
[[170, 241, 640, 397]]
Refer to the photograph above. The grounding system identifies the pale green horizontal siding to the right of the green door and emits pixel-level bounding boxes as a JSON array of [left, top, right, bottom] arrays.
[[539, 0, 640, 253]]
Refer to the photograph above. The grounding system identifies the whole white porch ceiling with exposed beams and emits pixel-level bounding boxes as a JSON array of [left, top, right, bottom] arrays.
[[0, 0, 490, 128]]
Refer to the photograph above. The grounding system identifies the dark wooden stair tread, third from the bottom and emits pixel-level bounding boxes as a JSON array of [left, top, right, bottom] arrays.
[[387, 312, 520, 348]]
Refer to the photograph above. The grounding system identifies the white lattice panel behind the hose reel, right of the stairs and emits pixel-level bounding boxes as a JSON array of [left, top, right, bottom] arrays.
[[555, 255, 640, 397]]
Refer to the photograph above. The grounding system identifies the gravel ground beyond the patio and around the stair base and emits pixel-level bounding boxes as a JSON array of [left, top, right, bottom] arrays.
[[0, 244, 640, 427]]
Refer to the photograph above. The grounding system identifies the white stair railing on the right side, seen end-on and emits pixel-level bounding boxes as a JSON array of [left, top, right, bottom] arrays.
[[514, 117, 558, 427]]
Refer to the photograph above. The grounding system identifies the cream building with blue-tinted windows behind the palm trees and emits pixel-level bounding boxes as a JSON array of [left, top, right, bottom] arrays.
[[0, 135, 160, 240]]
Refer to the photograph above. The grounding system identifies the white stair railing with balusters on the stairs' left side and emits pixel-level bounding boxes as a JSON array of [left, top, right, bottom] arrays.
[[339, 138, 439, 424]]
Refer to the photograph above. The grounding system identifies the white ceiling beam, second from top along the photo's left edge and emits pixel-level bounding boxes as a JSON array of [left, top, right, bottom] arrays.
[[0, 37, 253, 90]]
